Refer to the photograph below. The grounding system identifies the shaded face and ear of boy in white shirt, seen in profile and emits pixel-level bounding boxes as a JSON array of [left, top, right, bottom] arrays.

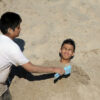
[[8, 24, 21, 38]]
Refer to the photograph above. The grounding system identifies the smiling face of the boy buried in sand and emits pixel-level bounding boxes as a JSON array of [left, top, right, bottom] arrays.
[[60, 44, 74, 60]]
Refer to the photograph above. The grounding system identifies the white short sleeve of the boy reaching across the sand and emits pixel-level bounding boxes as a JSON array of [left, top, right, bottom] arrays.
[[8, 45, 29, 66]]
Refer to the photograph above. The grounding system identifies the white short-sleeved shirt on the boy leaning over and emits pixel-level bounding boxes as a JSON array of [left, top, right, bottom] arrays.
[[0, 35, 29, 96]]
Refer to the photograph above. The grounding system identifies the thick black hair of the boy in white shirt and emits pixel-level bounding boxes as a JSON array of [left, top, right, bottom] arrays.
[[0, 12, 22, 34]]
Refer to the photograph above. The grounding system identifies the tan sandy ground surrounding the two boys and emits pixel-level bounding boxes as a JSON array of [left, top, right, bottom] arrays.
[[0, 0, 100, 100]]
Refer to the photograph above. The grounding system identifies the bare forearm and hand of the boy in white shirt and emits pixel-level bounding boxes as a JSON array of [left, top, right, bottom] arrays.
[[22, 62, 65, 75]]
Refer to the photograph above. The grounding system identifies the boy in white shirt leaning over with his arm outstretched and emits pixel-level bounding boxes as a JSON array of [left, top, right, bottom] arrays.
[[0, 12, 65, 100]]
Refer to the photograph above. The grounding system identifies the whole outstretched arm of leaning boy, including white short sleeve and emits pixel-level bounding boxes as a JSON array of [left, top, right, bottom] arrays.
[[9, 45, 64, 74]]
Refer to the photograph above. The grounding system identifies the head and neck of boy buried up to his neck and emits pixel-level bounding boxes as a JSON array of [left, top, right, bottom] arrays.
[[59, 39, 75, 65]]
